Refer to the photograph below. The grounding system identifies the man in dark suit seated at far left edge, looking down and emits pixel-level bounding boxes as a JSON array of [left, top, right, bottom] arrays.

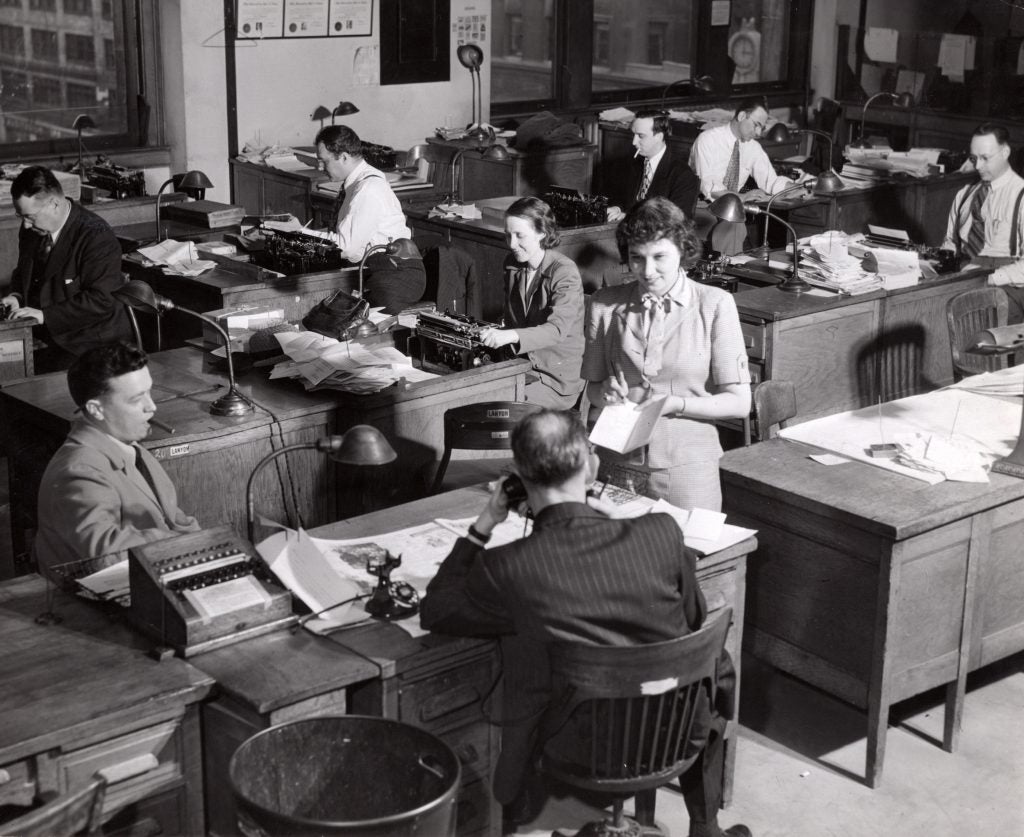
[[0, 166, 132, 372]]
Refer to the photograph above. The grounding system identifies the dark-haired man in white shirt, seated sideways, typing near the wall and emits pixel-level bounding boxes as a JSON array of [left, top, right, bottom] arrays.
[[316, 125, 427, 313]]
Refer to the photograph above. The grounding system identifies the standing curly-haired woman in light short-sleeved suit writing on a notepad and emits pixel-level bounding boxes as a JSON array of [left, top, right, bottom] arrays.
[[583, 198, 751, 511]]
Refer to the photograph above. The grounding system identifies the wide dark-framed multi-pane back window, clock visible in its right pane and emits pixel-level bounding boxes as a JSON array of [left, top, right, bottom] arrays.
[[490, 0, 814, 116]]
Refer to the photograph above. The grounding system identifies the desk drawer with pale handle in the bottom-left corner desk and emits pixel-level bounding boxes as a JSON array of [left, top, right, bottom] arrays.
[[57, 721, 184, 815]]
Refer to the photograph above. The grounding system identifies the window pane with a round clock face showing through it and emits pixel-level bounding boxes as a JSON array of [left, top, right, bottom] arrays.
[[729, 0, 790, 84]]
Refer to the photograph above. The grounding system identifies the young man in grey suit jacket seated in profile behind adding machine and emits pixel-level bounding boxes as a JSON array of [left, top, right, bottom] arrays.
[[34, 343, 200, 573]]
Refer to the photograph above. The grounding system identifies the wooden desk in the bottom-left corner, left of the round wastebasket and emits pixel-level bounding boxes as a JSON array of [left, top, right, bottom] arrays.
[[0, 576, 213, 834]]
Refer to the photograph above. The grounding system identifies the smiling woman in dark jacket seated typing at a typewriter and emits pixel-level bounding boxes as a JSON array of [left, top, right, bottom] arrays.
[[480, 198, 584, 410]]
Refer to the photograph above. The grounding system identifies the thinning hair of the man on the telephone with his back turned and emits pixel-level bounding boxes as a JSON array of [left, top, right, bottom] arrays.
[[512, 410, 590, 488]]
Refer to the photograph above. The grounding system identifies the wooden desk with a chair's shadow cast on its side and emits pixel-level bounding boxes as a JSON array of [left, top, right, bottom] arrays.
[[728, 262, 988, 421]]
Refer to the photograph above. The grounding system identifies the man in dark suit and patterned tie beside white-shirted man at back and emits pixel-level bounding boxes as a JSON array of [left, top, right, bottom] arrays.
[[608, 110, 700, 221]]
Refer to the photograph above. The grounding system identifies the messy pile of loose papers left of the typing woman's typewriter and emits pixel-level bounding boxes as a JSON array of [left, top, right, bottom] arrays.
[[270, 327, 438, 393]]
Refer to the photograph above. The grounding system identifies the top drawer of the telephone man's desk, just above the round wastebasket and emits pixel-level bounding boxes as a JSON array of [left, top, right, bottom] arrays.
[[398, 662, 494, 729]]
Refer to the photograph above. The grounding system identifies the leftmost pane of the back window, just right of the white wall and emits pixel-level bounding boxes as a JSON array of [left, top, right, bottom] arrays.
[[489, 0, 555, 104]]
